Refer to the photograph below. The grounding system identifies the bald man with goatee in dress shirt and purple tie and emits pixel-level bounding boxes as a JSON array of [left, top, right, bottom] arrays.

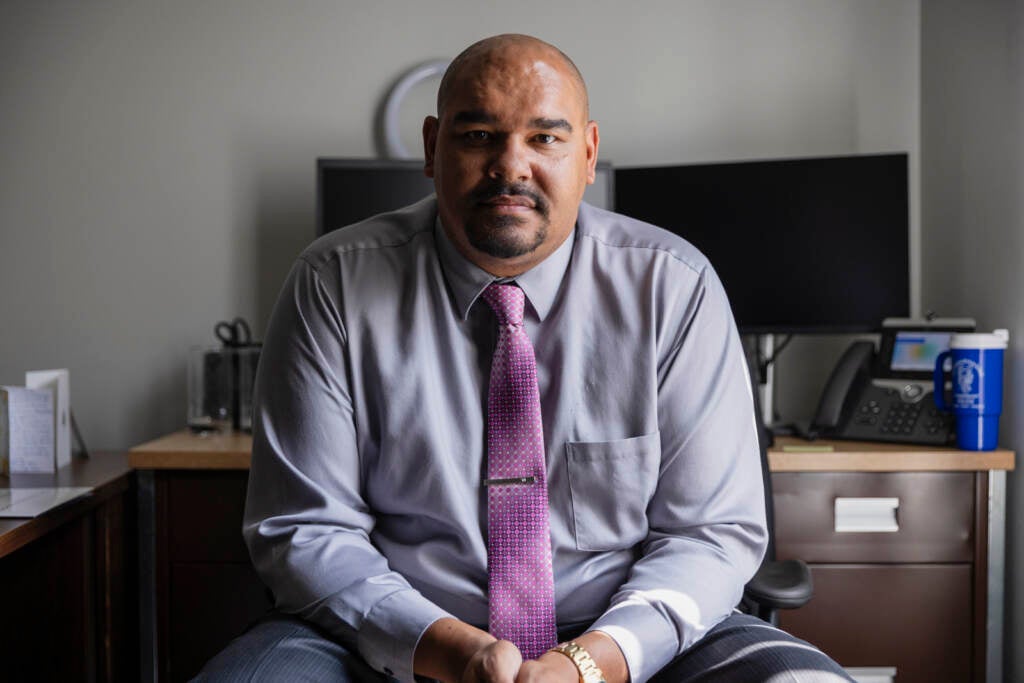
[[200, 35, 848, 683]]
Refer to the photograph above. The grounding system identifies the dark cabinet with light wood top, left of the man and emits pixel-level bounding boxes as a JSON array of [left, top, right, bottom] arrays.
[[128, 432, 271, 682]]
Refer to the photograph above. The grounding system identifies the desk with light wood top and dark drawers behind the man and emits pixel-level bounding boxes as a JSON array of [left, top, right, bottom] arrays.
[[129, 432, 1014, 683]]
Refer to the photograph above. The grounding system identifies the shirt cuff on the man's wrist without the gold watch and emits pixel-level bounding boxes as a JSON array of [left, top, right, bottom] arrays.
[[356, 589, 451, 683]]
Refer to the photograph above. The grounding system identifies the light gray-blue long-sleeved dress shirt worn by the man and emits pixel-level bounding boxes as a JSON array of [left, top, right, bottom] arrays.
[[244, 198, 767, 683]]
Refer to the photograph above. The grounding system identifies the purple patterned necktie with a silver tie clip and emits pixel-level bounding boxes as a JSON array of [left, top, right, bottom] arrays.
[[481, 285, 557, 659]]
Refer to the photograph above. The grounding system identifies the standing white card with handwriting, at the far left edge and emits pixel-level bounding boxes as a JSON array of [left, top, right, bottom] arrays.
[[0, 386, 55, 472]]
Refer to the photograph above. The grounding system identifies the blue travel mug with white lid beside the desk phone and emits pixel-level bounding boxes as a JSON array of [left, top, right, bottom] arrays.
[[934, 330, 1010, 451]]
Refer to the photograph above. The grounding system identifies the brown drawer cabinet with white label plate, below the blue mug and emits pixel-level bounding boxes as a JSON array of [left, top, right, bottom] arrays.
[[771, 444, 1013, 683]]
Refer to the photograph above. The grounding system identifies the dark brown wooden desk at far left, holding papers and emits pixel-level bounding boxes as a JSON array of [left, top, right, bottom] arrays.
[[0, 454, 137, 681]]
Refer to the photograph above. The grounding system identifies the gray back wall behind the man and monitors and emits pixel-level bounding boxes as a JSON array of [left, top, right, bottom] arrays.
[[0, 0, 919, 449]]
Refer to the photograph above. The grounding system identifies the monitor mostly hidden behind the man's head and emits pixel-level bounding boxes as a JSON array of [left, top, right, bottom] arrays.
[[316, 159, 614, 236]]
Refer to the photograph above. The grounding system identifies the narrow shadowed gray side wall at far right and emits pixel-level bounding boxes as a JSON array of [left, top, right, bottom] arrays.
[[921, 0, 1024, 681]]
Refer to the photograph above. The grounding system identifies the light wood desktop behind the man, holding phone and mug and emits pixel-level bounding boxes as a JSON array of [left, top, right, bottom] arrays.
[[128, 430, 1014, 472]]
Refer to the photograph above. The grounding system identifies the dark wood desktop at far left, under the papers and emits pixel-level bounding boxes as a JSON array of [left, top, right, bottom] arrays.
[[0, 453, 132, 557]]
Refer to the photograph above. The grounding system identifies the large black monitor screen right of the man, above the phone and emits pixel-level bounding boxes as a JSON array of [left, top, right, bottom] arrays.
[[615, 154, 910, 333]]
